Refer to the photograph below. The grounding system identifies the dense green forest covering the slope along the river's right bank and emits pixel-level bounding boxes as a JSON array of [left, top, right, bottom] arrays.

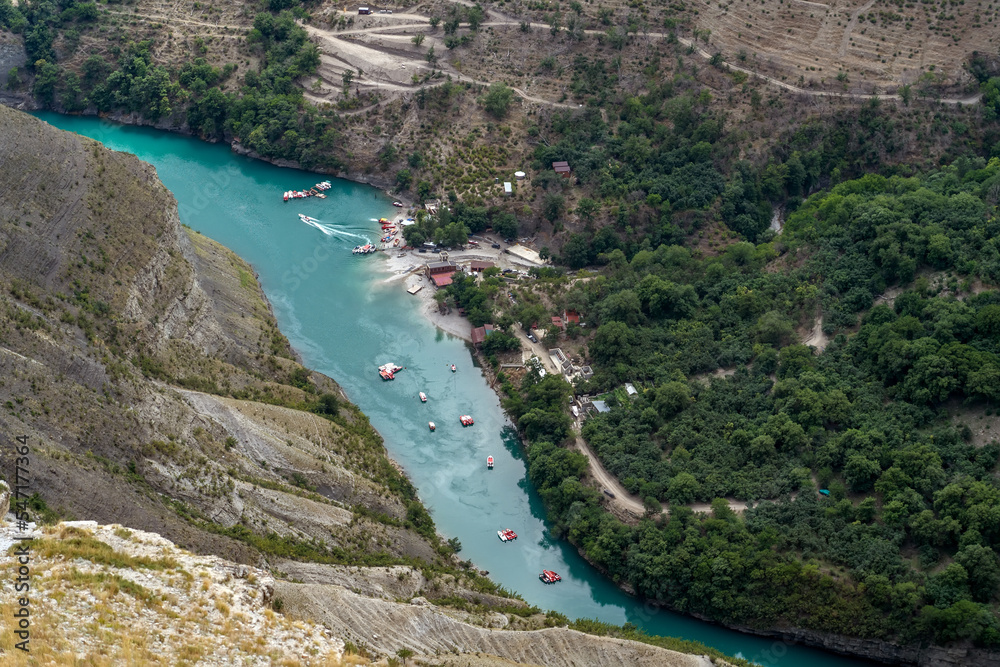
[[505, 159, 1000, 645]]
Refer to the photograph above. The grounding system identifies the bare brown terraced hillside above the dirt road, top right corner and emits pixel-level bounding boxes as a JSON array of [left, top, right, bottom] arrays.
[[691, 0, 1000, 92]]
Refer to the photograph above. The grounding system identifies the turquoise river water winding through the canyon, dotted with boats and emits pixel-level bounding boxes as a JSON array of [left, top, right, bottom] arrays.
[[37, 113, 872, 667]]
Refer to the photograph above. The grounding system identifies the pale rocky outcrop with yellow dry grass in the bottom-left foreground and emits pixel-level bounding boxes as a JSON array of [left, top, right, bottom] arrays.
[[0, 521, 344, 667]]
